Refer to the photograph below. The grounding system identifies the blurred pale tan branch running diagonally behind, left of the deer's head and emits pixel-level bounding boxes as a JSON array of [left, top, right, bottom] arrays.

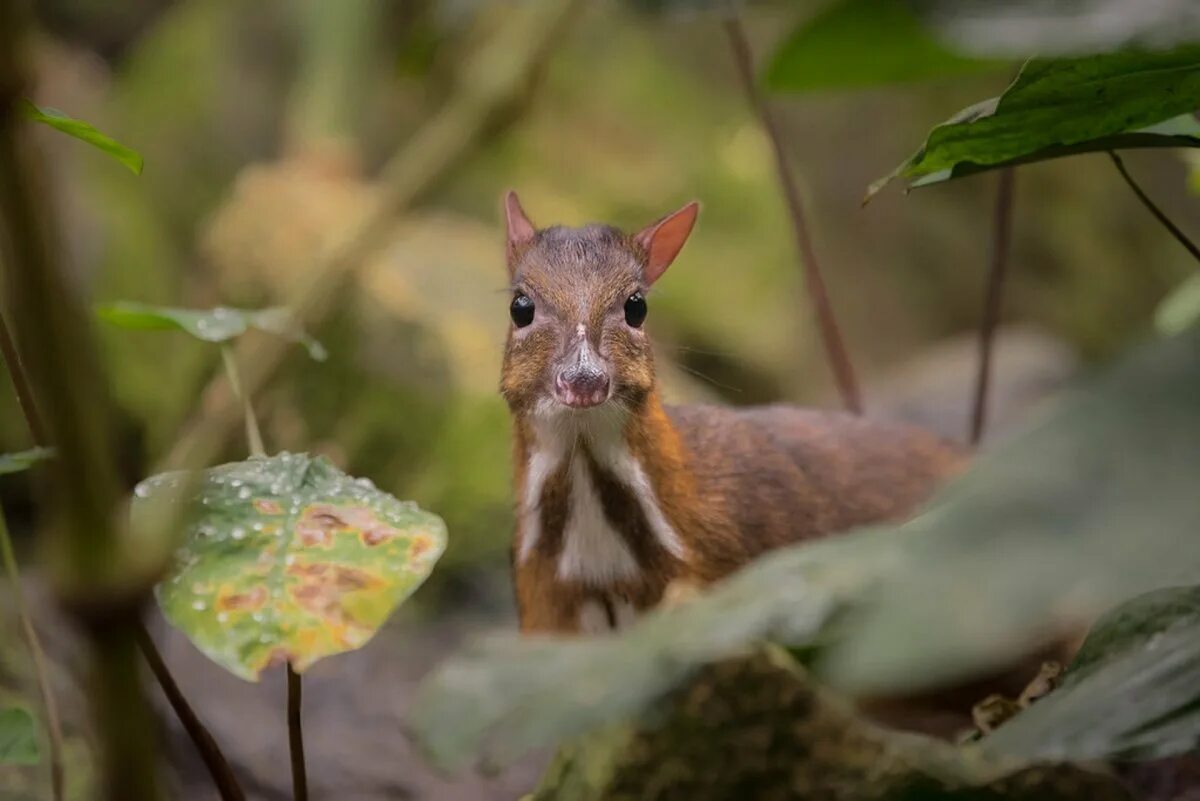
[[155, 0, 581, 472]]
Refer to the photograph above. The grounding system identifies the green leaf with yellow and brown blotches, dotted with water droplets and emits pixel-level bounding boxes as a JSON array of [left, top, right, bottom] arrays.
[[140, 453, 446, 681]]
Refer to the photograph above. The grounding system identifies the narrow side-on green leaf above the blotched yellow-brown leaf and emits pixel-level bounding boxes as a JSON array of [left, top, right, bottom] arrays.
[[96, 302, 328, 361]]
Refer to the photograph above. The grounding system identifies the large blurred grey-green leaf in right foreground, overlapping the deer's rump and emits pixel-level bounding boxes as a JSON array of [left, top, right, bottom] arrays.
[[822, 329, 1200, 693]]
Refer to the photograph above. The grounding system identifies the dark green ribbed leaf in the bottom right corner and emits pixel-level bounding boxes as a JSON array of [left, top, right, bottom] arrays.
[[984, 586, 1200, 760]]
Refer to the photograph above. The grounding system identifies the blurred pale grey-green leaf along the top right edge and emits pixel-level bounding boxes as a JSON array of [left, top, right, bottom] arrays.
[[911, 0, 1200, 56]]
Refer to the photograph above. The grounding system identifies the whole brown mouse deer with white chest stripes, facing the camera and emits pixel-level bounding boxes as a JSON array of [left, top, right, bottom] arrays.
[[500, 193, 965, 632]]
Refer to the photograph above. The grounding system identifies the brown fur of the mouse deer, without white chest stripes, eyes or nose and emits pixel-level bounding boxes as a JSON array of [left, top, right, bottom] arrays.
[[500, 195, 965, 632]]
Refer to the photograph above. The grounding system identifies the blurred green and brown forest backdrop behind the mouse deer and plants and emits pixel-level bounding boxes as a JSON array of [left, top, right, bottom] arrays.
[[0, 0, 1200, 800]]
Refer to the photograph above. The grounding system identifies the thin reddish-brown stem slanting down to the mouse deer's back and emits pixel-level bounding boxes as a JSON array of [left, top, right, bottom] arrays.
[[724, 15, 863, 414]]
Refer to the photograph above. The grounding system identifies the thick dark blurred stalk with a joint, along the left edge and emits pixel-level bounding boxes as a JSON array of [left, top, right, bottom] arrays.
[[0, 0, 159, 801]]
